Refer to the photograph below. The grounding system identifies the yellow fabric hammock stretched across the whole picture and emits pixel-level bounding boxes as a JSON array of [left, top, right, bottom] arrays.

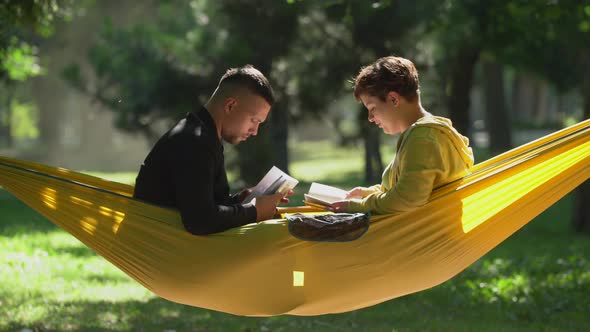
[[0, 120, 590, 316]]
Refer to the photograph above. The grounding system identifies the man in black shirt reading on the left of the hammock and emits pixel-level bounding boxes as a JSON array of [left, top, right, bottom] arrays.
[[134, 65, 290, 235]]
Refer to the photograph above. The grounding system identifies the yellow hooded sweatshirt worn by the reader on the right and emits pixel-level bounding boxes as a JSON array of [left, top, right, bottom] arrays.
[[348, 116, 473, 214]]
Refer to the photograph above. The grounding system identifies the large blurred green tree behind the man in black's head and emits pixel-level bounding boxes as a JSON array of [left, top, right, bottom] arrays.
[[64, 1, 308, 183]]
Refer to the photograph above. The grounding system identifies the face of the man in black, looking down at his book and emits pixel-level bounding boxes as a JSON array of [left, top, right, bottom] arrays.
[[221, 94, 270, 144]]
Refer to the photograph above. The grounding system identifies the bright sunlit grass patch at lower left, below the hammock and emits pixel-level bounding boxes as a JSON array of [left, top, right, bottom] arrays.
[[0, 230, 154, 330]]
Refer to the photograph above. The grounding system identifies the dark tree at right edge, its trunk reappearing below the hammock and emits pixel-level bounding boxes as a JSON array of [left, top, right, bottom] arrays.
[[492, 0, 590, 231]]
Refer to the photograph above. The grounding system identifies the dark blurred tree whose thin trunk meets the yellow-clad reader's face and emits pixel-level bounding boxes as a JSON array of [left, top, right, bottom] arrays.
[[289, 1, 440, 183]]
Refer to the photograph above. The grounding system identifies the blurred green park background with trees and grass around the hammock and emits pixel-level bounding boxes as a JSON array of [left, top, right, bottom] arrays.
[[0, 0, 590, 331]]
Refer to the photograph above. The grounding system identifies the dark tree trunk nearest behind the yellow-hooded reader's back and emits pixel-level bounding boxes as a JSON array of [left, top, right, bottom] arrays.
[[447, 46, 480, 136]]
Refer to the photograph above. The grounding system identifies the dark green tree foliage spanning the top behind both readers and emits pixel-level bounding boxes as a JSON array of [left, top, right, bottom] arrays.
[[59, 0, 590, 218]]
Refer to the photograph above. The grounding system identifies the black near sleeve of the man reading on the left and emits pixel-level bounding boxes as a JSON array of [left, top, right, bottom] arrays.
[[171, 142, 256, 235]]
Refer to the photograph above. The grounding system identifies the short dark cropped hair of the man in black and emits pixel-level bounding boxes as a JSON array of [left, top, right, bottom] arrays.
[[219, 65, 275, 106]]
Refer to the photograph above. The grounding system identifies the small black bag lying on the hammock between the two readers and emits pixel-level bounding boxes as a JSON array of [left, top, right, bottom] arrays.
[[287, 213, 370, 242]]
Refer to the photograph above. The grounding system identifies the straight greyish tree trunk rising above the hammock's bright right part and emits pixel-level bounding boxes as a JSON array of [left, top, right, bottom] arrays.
[[483, 60, 511, 155]]
